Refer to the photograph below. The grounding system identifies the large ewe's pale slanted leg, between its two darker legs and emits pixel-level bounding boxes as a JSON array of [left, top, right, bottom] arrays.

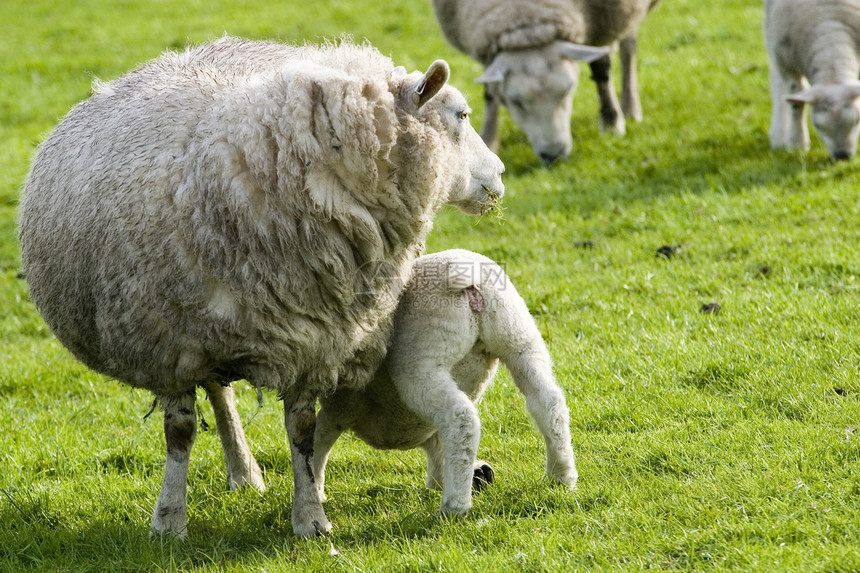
[[203, 383, 266, 491]]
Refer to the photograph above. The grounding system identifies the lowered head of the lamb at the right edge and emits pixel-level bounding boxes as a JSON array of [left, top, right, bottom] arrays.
[[786, 82, 860, 159]]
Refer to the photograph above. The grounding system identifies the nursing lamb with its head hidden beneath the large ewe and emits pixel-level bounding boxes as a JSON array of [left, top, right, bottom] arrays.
[[314, 250, 577, 515]]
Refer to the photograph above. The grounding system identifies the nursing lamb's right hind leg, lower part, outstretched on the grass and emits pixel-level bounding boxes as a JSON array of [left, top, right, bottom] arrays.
[[502, 350, 578, 489]]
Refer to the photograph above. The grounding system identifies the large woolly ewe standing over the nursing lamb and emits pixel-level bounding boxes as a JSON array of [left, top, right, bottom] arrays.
[[20, 38, 504, 536]]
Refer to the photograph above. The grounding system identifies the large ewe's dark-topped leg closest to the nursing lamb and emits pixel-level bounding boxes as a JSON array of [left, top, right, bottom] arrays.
[[284, 394, 331, 537]]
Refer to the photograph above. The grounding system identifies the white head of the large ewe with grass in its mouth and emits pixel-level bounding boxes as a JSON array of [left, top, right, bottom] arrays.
[[405, 60, 505, 215]]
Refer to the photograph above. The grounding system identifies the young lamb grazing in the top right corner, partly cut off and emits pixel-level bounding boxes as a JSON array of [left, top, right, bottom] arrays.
[[764, 0, 860, 159]]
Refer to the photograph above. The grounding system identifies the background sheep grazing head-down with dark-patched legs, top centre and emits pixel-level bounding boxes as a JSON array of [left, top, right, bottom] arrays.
[[433, 0, 659, 164]]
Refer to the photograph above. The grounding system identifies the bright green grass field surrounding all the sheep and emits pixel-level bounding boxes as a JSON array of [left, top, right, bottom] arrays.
[[0, 0, 860, 572]]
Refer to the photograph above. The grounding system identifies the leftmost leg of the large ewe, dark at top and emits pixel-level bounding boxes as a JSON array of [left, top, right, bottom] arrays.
[[152, 391, 197, 538]]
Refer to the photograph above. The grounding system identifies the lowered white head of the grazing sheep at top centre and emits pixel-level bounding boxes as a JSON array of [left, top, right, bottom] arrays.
[[476, 41, 609, 165]]
